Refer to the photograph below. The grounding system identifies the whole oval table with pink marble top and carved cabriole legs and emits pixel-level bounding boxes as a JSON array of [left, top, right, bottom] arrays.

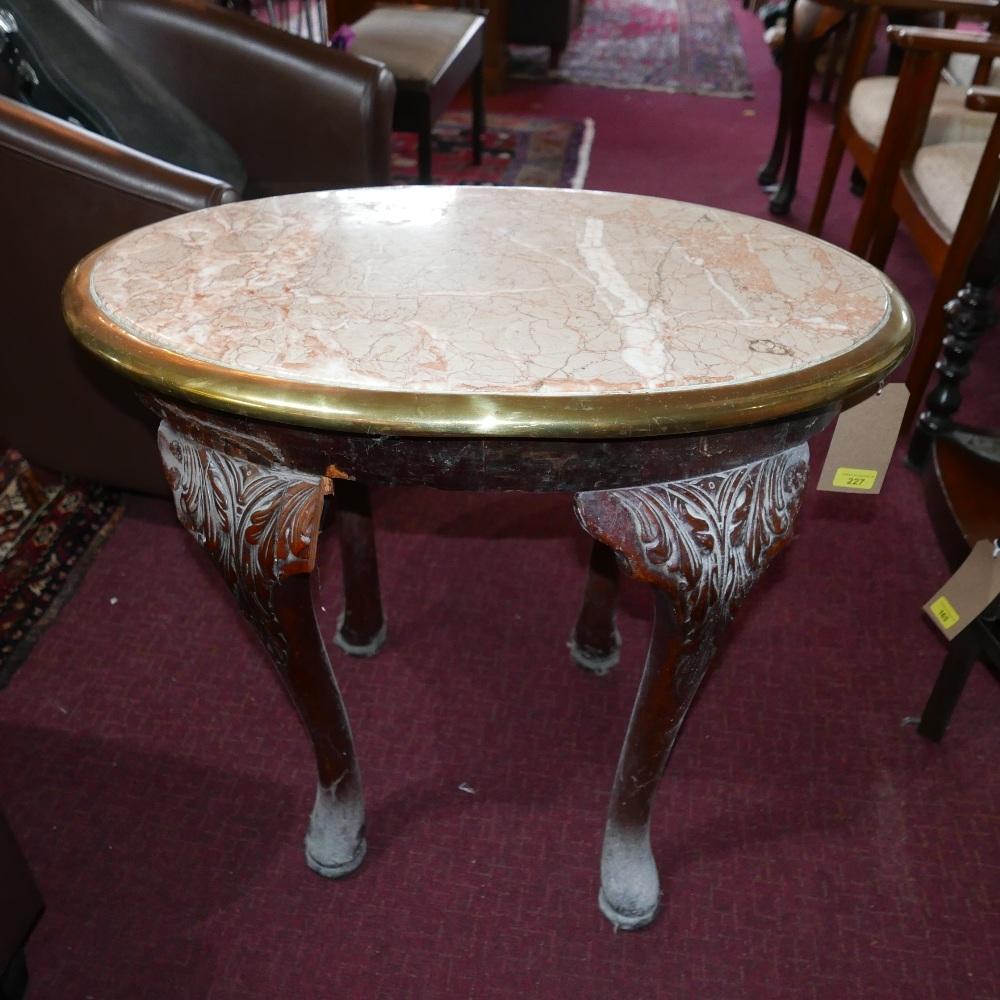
[[64, 187, 912, 928]]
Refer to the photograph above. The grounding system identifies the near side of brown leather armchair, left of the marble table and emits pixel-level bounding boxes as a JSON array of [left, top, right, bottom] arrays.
[[0, 97, 235, 493]]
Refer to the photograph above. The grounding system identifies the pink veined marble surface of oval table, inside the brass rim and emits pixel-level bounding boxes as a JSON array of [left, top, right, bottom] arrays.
[[91, 187, 889, 396]]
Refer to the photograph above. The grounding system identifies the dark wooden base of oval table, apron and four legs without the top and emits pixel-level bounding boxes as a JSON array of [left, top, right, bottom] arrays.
[[145, 393, 836, 928]]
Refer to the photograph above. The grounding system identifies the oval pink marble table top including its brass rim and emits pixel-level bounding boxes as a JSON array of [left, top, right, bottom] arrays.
[[67, 187, 911, 436]]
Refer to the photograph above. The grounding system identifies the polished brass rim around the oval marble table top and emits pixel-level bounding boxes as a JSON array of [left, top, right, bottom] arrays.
[[63, 248, 913, 438]]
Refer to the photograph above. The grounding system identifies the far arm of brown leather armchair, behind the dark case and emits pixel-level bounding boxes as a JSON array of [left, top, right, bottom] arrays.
[[91, 0, 395, 198]]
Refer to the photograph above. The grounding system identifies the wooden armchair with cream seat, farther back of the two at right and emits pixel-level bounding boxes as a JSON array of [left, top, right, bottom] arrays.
[[809, 0, 1000, 238]]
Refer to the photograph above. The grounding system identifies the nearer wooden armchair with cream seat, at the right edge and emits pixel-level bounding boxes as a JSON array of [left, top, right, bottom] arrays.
[[851, 28, 1000, 422]]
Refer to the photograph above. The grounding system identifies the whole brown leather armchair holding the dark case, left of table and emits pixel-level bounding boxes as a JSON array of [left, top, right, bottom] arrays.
[[0, 0, 395, 493]]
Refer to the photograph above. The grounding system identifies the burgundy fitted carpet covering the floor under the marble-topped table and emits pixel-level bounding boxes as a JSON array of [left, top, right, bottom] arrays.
[[0, 4, 1000, 1000]]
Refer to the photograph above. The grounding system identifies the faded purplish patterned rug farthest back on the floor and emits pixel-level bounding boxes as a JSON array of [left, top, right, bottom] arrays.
[[510, 0, 753, 97]]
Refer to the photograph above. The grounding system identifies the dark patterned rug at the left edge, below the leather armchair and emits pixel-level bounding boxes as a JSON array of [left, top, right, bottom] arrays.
[[0, 448, 122, 687]]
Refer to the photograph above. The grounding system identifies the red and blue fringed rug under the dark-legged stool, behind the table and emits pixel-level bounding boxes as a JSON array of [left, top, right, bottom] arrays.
[[392, 114, 594, 188]]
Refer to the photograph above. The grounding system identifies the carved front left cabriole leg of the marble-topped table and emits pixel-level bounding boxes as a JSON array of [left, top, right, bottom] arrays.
[[159, 421, 365, 878]]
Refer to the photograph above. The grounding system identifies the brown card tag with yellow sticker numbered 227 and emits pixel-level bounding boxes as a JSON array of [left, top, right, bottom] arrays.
[[818, 382, 910, 494]]
